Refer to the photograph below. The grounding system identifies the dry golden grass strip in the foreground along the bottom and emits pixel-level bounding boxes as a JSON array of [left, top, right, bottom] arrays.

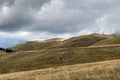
[[0, 60, 120, 80]]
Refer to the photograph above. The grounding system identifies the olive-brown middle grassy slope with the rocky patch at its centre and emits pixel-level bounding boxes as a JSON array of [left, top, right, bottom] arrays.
[[0, 46, 120, 73]]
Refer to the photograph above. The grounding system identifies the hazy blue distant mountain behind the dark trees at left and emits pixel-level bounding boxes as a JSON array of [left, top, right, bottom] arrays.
[[0, 38, 26, 48]]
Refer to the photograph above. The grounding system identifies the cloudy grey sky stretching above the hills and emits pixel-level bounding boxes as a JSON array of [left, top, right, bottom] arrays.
[[0, 0, 120, 40]]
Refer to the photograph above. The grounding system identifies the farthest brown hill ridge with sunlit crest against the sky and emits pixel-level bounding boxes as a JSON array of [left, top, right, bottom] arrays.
[[12, 34, 110, 51]]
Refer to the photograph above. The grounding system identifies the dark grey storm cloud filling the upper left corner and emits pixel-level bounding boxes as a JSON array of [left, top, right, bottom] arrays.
[[0, 0, 49, 31]]
